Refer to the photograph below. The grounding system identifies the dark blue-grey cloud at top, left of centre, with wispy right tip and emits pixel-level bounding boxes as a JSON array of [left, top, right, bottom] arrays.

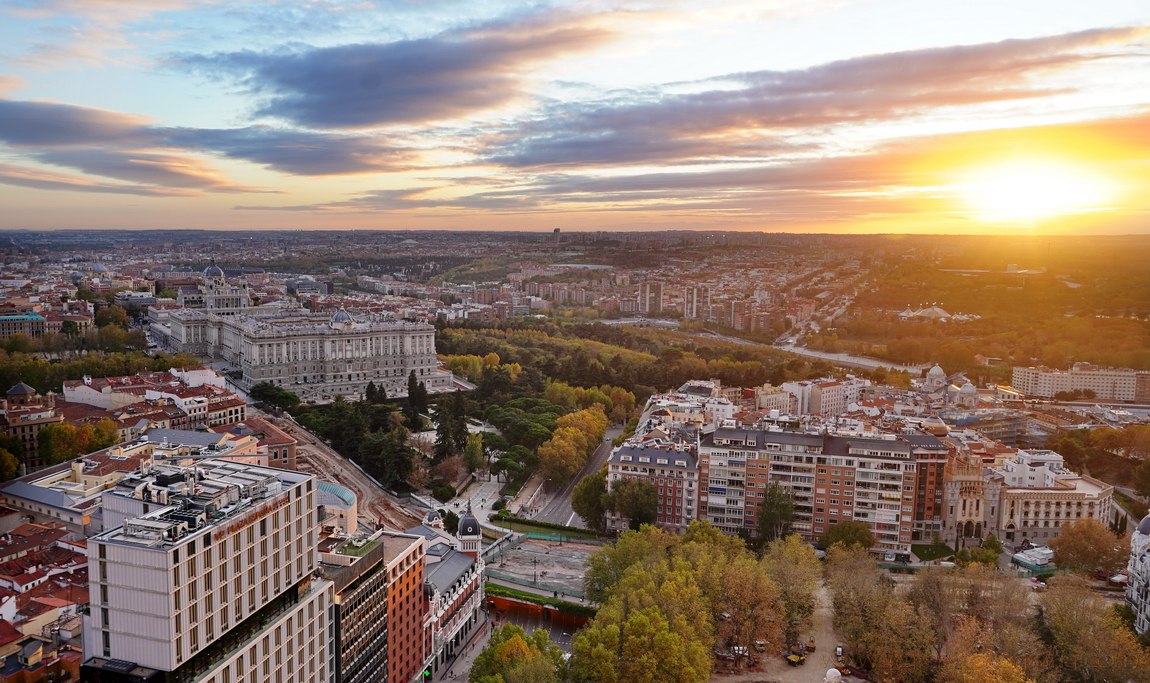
[[176, 13, 610, 129]]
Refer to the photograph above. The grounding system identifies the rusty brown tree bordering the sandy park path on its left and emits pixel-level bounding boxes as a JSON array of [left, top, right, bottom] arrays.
[[762, 534, 822, 643]]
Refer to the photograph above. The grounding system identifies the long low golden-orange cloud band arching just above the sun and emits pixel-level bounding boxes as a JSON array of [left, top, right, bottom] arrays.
[[238, 113, 1150, 220]]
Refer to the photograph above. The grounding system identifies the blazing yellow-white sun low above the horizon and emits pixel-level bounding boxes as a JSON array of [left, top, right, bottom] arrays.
[[958, 160, 1112, 225]]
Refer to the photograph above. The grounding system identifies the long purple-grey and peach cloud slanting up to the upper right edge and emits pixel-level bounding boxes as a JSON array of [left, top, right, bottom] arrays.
[[486, 29, 1147, 167]]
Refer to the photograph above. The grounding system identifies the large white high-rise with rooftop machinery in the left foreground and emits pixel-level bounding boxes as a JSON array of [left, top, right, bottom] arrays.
[[83, 461, 336, 683]]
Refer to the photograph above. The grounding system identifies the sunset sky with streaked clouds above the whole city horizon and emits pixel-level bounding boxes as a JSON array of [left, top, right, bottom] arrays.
[[0, 0, 1150, 235]]
